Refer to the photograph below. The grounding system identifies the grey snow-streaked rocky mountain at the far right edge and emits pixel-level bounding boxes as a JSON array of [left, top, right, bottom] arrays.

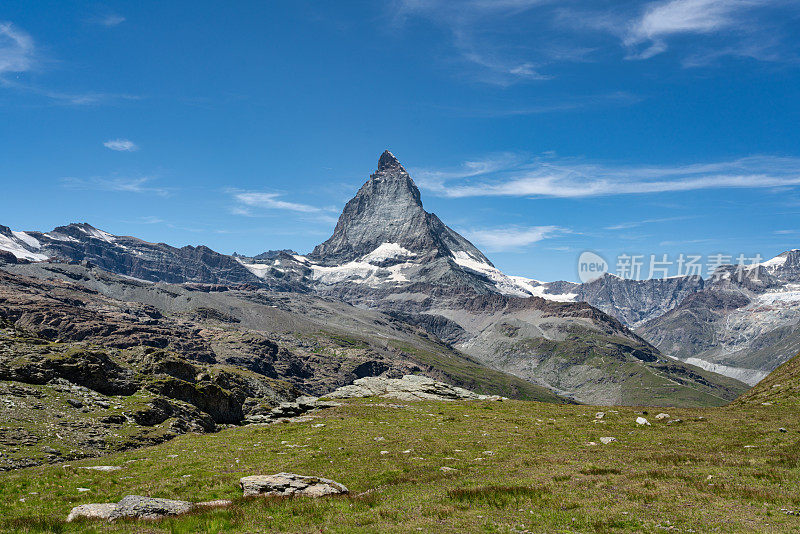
[[638, 254, 800, 384]]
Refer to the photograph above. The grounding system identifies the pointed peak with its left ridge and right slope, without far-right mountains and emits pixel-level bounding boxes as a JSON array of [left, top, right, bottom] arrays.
[[0, 151, 743, 405]]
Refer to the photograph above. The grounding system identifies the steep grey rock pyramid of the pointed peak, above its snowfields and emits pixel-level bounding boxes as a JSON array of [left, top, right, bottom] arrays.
[[309, 151, 491, 265]]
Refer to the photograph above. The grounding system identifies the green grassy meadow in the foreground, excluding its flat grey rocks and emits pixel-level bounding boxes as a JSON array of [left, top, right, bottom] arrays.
[[0, 399, 800, 533]]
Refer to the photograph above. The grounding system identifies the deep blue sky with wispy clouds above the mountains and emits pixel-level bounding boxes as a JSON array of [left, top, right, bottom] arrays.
[[0, 0, 800, 280]]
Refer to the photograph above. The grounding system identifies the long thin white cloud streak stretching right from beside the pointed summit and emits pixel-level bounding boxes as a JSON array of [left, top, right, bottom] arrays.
[[412, 156, 800, 198]]
